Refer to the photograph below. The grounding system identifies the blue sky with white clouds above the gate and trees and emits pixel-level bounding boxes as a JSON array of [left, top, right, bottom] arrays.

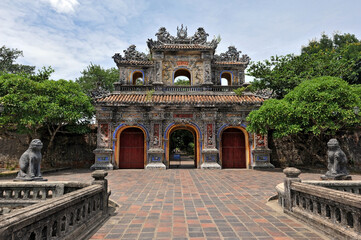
[[0, 0, 361, 80]]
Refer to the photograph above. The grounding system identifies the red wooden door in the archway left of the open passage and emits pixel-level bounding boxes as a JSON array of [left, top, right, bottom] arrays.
[[119, 128, 144, 169]]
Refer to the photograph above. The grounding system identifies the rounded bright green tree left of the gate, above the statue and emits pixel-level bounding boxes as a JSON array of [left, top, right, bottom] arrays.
[[0, 74, 94, 151]]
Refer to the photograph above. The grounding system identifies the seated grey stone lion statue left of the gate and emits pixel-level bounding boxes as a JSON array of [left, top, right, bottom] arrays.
[[17, 139, 43, 180]]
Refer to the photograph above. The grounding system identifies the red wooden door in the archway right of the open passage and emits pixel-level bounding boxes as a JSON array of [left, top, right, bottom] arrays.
[[222, 128, 246, 168]]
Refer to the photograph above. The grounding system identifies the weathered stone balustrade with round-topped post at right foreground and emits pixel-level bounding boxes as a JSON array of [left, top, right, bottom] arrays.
[[276, 170, 361, 239]]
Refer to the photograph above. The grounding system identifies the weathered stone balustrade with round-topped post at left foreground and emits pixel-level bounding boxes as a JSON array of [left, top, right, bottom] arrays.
[[0, 171, 110, 240]]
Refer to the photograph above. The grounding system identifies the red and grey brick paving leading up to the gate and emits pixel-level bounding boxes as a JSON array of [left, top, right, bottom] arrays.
[[14, 169, 361, 240]]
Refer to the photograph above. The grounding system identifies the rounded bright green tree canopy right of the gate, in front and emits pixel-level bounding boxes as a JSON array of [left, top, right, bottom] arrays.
[[247, 77, 361, 137]]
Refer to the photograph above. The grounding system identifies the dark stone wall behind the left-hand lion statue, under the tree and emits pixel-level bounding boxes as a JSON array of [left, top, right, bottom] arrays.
[[0, 129, 96, 169]]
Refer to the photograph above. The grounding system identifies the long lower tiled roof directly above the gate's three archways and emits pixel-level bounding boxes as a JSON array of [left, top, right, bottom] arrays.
[[97, 94, 264, 105]]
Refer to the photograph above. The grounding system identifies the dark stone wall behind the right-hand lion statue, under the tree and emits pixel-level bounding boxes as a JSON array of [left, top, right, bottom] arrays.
[[269, 128, 361, 172]]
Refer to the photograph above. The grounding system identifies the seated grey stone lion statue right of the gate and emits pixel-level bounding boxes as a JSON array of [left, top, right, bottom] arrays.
[[321, 138, 351, 180]]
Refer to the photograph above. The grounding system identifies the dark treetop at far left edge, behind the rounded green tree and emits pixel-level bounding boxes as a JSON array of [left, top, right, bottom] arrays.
[[0, 46, 35, 74]]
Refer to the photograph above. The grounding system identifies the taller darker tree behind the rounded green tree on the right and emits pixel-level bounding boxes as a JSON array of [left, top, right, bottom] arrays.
[[248, 34, 361, 99]]
